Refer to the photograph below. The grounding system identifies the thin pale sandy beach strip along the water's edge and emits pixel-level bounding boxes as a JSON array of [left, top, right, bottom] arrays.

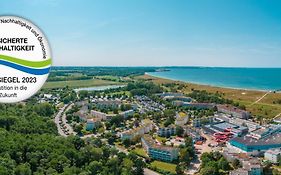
[[145, 72, 281, 93]]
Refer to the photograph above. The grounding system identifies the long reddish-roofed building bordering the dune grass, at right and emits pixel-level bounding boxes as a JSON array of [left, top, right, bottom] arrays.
[[217, 105, 251, 119]]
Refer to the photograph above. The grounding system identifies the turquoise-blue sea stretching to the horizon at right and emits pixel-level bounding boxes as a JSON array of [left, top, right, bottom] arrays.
[[146, 67, 281, 91]]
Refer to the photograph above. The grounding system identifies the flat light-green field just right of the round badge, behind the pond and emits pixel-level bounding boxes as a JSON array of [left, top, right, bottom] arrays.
[[43, 79, 121, 89]]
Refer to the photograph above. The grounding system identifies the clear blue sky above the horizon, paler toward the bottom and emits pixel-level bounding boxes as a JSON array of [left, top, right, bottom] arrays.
[[0, 0, 281, 67]]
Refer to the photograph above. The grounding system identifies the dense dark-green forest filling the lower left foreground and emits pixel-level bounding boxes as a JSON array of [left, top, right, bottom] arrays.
[[0, 103, 144, 175]]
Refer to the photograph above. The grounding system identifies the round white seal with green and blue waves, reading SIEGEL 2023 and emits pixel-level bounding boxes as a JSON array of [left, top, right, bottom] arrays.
[[0, 16, 51, 103]]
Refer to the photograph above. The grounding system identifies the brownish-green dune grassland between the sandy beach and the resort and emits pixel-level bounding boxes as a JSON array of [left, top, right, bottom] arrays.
[[135, 75, 281, 119]]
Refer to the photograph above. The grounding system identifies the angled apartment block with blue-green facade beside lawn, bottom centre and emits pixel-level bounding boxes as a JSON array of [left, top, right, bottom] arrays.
[[141, 135, 179, 162]]
